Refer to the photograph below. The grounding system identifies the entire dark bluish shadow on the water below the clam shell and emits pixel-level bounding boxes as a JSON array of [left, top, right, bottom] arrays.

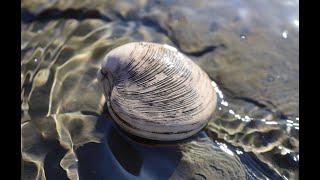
[[76, 109, 182, 179]]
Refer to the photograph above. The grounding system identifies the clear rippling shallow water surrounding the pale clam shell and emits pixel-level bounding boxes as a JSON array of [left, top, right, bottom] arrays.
[[21, 0, 299, 179]]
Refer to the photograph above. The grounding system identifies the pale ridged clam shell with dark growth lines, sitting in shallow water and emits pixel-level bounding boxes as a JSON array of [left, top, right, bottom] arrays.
[[98, 42, 217, 141]]
